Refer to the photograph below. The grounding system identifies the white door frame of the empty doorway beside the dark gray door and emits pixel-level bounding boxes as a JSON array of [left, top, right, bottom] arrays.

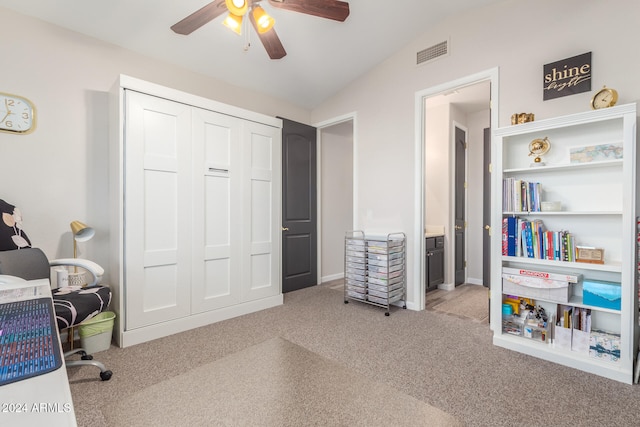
[[311, 111, 358, 284]]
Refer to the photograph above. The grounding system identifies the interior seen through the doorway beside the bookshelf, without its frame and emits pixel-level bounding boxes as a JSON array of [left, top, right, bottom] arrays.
[[424, 81, 490, 290]]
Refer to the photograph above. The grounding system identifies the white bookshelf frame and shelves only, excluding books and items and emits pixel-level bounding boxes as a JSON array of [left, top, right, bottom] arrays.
[[491, 104, 639, 383]]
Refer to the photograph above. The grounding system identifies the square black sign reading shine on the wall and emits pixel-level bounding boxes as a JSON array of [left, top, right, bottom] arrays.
[[542, 52, 591, 101]]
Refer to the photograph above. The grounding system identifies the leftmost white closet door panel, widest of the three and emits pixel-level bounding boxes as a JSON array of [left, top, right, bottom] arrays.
[[124, 91, 192, 329]]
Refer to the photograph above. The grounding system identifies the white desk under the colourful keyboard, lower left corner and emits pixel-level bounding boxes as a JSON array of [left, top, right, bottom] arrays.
[[0, 279, 77, 427]]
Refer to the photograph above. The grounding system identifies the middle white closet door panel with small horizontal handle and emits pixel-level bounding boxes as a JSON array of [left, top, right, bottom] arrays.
[[192, 109, 242, 313]]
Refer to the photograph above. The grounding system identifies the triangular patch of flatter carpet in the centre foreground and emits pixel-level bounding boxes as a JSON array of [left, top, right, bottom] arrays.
[[103, 338, 462, 427]]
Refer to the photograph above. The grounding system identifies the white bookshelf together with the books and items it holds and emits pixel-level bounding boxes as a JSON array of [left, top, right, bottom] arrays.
[[491, 104, 640, 384]]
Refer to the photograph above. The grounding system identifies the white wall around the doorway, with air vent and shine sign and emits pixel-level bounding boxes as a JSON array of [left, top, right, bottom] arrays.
[[312, 0, 640, 308]]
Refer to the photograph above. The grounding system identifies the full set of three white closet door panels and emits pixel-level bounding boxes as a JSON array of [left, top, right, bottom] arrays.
[[124, 91, 281, 329]]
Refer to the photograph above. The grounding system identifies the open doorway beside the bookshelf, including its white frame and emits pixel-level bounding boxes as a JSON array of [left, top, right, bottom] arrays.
[[416, 69, 498, 332]]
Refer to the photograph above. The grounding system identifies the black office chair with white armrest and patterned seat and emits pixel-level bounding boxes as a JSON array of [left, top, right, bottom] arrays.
[[0, 247, 112, 381]]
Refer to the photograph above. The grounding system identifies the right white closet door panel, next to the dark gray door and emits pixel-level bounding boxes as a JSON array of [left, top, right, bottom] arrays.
[[242, 122, 281, 300]]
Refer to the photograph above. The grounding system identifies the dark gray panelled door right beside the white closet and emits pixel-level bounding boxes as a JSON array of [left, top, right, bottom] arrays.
[[282, 119, 318, 292]]
